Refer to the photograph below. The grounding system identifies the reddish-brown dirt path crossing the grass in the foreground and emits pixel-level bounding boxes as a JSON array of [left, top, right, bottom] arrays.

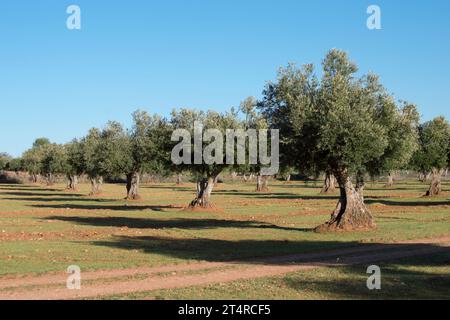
[[0, 237, 450, 300]]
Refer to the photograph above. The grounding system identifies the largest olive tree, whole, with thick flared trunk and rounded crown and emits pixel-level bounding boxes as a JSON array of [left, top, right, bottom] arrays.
[[261, 49, 418, 231]]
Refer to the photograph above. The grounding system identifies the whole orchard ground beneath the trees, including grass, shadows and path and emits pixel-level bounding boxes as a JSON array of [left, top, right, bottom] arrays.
[[0, 179, 450, 299]]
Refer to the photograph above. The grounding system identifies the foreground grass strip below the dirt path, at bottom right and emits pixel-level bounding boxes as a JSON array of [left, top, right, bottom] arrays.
[[112, 253, 450, 300]]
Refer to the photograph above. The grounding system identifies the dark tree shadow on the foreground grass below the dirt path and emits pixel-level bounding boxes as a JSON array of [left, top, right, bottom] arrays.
[[280, 252, 450, 299]]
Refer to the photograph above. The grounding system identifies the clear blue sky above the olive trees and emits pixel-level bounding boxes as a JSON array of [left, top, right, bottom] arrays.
[[0, 0, 450, 156]]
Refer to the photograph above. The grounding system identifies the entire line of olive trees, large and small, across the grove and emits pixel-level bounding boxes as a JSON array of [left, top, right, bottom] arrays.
[[1, 50, 450, 231]]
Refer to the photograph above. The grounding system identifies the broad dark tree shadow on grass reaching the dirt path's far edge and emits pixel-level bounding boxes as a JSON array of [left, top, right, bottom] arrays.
[[92, 234, 448, 265]]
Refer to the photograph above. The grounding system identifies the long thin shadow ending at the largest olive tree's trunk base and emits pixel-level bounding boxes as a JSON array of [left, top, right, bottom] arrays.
[[46, 216, 312, 232]]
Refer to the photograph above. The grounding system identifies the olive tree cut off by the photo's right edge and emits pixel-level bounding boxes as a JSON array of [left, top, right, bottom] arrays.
[[411, 117, 450, 196]]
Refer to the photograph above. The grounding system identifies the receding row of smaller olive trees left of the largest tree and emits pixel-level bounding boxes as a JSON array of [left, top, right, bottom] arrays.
[[0, 109, 252, 208]]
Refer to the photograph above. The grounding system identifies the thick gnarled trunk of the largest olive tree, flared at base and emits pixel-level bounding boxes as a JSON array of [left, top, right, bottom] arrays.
[[315, 172, 376, 232]]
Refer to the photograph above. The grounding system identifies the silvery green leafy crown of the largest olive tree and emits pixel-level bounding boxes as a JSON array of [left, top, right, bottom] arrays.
[[259, 49, 417, 178]]
